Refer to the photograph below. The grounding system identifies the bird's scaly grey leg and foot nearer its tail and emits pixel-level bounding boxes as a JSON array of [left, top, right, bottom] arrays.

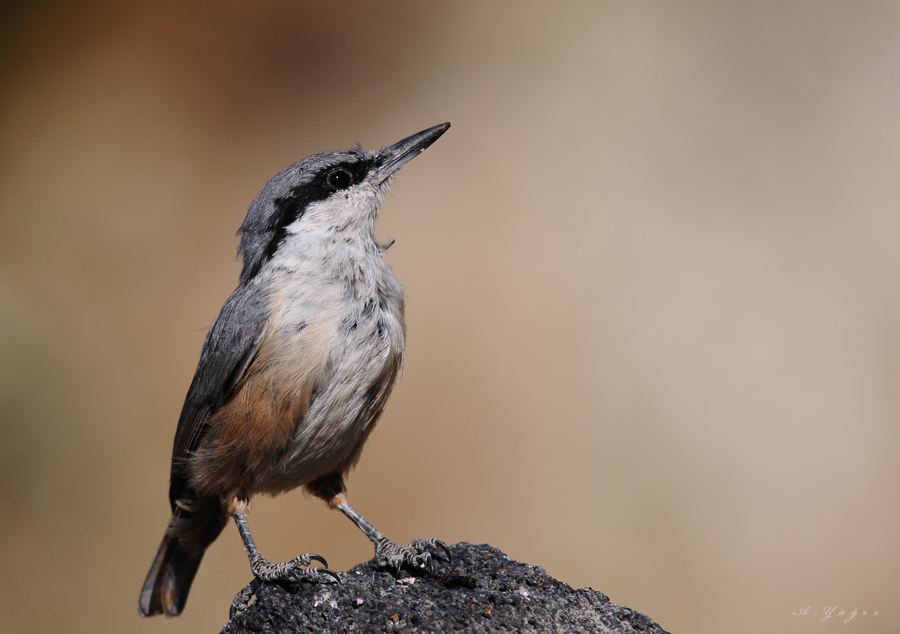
[[231, 498, 341, 616]]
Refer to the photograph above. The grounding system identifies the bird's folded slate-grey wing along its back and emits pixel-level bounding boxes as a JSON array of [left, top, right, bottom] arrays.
[[169, 284, 267, 509]]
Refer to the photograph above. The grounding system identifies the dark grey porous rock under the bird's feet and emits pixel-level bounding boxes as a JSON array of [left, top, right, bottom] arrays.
[[222, 542, 665, 634]]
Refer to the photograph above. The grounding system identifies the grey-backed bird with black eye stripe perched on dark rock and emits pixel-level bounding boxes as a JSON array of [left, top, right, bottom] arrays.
[[139, 123, 450, 617]]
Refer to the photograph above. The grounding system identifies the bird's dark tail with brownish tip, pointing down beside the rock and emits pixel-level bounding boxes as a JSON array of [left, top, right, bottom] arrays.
[[139, 498, 228, 616]]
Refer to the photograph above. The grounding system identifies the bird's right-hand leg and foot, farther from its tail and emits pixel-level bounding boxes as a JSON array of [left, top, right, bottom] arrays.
[[308, 476, 450, 572]]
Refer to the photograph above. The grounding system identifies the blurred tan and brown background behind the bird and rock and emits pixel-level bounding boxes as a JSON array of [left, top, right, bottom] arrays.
[[0, 0, 900, 634]]
